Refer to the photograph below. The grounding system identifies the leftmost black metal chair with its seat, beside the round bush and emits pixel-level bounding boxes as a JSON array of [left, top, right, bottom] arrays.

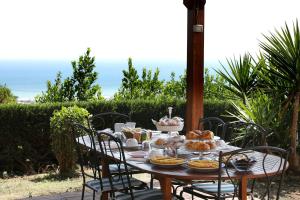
[[72, 123, 147, 199]]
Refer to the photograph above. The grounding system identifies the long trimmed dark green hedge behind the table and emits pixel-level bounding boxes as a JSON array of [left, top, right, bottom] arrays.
[[0, 100, 232, 175]]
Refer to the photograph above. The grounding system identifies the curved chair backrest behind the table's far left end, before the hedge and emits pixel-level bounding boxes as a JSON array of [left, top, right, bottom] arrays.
[[88, 112, 131, 130]]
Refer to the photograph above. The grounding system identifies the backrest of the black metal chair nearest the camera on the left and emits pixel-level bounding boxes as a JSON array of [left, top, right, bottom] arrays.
[[97, 132, 133, 199]]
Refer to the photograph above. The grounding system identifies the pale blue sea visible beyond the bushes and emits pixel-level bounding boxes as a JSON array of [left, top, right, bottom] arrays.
[[0, 59, 220, 101]]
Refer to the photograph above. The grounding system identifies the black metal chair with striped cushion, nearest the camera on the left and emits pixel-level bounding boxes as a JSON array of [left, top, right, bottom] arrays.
[[98, 132, 178, 200]]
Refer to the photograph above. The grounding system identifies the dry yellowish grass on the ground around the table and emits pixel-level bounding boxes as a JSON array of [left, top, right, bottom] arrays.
[[0, 170, 300, 200]]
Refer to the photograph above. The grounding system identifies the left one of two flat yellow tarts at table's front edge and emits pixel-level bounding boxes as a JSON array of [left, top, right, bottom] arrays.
[[150, 156, 185, 167]]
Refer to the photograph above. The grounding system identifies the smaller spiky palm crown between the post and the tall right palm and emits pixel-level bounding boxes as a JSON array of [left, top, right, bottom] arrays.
[[216, 53, 257, 104]]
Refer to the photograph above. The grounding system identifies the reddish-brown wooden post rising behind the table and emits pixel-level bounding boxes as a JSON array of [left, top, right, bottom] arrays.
[[183, 0, 206, 131]]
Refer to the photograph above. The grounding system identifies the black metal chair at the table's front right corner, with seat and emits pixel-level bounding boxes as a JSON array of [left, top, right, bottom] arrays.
[[181, 146, 289, 199]]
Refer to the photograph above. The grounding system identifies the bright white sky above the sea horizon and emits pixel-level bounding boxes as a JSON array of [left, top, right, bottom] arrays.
[[0, 0, 300, 61]]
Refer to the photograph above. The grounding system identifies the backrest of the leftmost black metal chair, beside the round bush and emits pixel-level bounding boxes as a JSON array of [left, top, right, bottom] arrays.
[[72, 123, 103, 189]]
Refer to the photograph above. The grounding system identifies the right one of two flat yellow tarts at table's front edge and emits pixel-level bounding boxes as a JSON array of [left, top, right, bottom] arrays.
[[187, 160, 219, 172]]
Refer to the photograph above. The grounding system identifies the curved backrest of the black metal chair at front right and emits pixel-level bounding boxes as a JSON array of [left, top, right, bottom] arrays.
[[218, 146, 289, 199]]
